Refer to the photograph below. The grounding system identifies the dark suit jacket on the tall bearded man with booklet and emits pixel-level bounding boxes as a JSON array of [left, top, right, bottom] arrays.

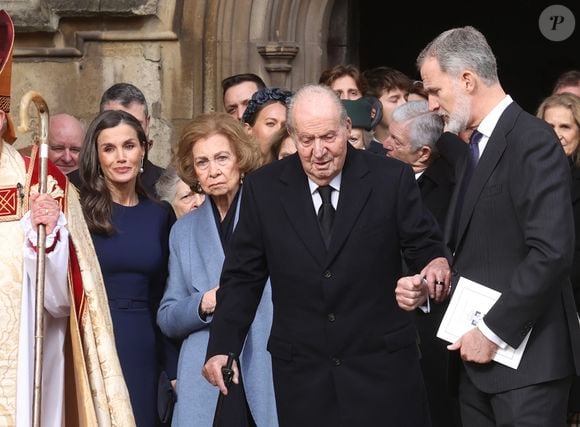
[[446, 103, 580, 393]]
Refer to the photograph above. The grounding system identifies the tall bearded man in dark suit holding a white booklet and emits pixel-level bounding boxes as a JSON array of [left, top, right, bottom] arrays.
[[417, 27, 580, 426]]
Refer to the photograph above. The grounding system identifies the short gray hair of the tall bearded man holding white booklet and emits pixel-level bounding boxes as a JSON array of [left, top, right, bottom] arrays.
[[417, 26, 499, 86]]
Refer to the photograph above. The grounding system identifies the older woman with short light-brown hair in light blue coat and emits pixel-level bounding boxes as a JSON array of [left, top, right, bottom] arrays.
[[157, 113, 278, 427]]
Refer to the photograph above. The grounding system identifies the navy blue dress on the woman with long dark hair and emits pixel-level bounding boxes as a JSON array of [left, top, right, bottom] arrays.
[[92, 198, 176, 427]]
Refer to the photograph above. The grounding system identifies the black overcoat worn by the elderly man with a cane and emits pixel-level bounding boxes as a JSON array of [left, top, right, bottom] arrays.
[[208, 145, 443, 427]]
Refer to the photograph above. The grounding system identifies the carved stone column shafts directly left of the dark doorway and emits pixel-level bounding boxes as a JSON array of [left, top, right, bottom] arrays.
[[197, 0, 334, 111]]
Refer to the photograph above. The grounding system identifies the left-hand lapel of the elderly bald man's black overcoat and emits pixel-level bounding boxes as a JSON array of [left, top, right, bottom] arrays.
[[280, 155, 326, 264]]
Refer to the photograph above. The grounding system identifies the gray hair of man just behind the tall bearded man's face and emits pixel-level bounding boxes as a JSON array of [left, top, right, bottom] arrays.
[[393, 101, 444, 153]]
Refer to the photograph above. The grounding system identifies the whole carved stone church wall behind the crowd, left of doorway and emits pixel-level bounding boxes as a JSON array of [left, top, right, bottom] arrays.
[[2, 0, 334, 166]]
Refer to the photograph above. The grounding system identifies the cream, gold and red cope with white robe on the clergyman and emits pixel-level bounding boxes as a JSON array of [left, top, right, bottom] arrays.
[[0, 140, 135, 427]]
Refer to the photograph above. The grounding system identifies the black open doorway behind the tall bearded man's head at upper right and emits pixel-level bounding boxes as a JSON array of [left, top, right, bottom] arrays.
[[352, 0, 580, 112]]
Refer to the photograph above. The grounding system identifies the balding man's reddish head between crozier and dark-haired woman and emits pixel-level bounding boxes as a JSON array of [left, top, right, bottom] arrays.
[[48, 114, 85, 174]]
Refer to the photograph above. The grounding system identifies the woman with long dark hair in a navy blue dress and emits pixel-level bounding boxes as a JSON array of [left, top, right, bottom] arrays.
[[80, 110, 176, 427]]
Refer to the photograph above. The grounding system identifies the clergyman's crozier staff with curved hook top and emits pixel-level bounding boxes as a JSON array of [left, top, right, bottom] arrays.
[[18, 91, 48, 427]]
